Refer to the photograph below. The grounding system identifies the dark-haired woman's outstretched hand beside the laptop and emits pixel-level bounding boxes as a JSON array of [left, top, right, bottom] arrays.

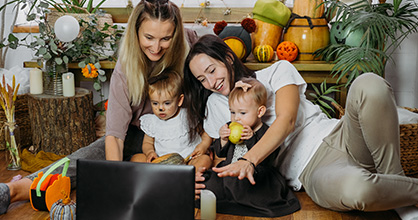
[[212, 160, 255, 185]]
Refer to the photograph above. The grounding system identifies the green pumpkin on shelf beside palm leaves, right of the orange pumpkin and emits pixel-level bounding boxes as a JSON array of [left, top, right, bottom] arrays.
[[330, 21, 364, 47]]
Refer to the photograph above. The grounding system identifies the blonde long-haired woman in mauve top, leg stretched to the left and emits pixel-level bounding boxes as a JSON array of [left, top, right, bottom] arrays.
[[0, 0, 202, 215]]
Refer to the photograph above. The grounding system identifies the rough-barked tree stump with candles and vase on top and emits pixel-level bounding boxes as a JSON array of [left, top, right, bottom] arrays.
[[28, 88, 96, 155]]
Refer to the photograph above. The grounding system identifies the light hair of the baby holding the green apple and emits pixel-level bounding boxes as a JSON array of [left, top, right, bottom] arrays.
[[228, 78, 267, 106]]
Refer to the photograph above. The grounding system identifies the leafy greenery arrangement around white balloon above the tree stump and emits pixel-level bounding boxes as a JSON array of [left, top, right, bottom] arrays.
[[0, 0, 122, 95]]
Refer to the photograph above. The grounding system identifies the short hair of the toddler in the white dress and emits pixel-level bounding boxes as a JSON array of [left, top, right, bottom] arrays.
[[148, 69, 183, 97]]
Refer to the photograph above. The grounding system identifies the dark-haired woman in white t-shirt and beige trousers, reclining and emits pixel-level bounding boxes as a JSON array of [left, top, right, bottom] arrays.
[[184, 35, 418, 217]]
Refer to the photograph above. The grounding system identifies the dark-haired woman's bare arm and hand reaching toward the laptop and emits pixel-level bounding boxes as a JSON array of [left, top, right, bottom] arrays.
[[213, 85, 300, 184]]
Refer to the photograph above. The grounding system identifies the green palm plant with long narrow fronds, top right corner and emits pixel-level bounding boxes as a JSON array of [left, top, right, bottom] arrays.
[[315, 0, 418, 86]]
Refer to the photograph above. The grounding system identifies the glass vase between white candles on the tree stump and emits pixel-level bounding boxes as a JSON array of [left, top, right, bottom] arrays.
[[44, 59, 68, 95]]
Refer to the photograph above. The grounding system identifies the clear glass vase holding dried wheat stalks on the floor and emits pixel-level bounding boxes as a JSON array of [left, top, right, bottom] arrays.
[[4, 122, 21, 170]]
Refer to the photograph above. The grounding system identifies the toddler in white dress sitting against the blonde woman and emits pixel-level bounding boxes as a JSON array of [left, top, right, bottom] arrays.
[[131, 70, 212, 170]]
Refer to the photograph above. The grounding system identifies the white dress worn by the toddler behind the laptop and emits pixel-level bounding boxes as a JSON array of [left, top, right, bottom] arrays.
[[139, 108, 201, 158]]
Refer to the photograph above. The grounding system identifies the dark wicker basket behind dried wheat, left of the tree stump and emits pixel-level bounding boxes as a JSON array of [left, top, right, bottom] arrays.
[[0, 94, 32, 150]]
